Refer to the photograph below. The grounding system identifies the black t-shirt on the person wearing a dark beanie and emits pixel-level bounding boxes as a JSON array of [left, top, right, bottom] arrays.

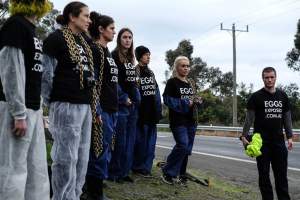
[[139, 66, 160, 124]]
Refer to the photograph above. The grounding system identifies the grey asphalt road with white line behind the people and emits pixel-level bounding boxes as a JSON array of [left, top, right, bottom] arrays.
[[156, 132, 300, 200]]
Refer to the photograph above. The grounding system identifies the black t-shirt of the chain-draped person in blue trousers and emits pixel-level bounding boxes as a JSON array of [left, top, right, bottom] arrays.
[[92, 44, 118, 113]]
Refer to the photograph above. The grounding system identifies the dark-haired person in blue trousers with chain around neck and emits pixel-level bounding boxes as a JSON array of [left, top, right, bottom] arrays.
[[81, 12, 118, 200]]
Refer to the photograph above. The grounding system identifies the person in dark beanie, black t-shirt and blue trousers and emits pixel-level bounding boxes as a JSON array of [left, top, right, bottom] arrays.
[[132, 46, 161, 177]]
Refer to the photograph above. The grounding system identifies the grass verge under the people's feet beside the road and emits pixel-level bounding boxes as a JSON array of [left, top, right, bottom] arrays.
[[105, 161, 259, 200]]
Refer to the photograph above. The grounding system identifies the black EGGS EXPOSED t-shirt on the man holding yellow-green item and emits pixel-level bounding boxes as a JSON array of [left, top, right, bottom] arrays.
[[247, 88, 290, 142]]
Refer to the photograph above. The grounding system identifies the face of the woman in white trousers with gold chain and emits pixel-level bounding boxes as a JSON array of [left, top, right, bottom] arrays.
[[70, 7, 91, 32]]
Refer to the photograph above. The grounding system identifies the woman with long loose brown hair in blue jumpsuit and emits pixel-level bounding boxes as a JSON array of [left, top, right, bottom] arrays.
[[109, 28, 141, 182]]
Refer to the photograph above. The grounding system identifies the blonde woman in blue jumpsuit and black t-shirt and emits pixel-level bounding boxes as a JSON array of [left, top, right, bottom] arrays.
[[161, 56, 201, 185]]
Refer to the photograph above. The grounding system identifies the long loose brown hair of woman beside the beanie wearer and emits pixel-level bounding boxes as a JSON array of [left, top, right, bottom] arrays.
[[115, 28, 134, 64]]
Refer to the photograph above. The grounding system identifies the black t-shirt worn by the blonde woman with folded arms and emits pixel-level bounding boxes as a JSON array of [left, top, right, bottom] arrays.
[[163, 77, 195, 127]]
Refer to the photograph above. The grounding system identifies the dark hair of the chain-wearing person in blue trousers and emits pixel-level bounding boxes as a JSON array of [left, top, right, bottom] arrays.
[[89, 11, 114, 39]]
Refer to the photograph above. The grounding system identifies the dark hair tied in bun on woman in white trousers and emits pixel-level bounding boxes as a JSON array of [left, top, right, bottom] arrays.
[[56, 1, 88, 25]]
